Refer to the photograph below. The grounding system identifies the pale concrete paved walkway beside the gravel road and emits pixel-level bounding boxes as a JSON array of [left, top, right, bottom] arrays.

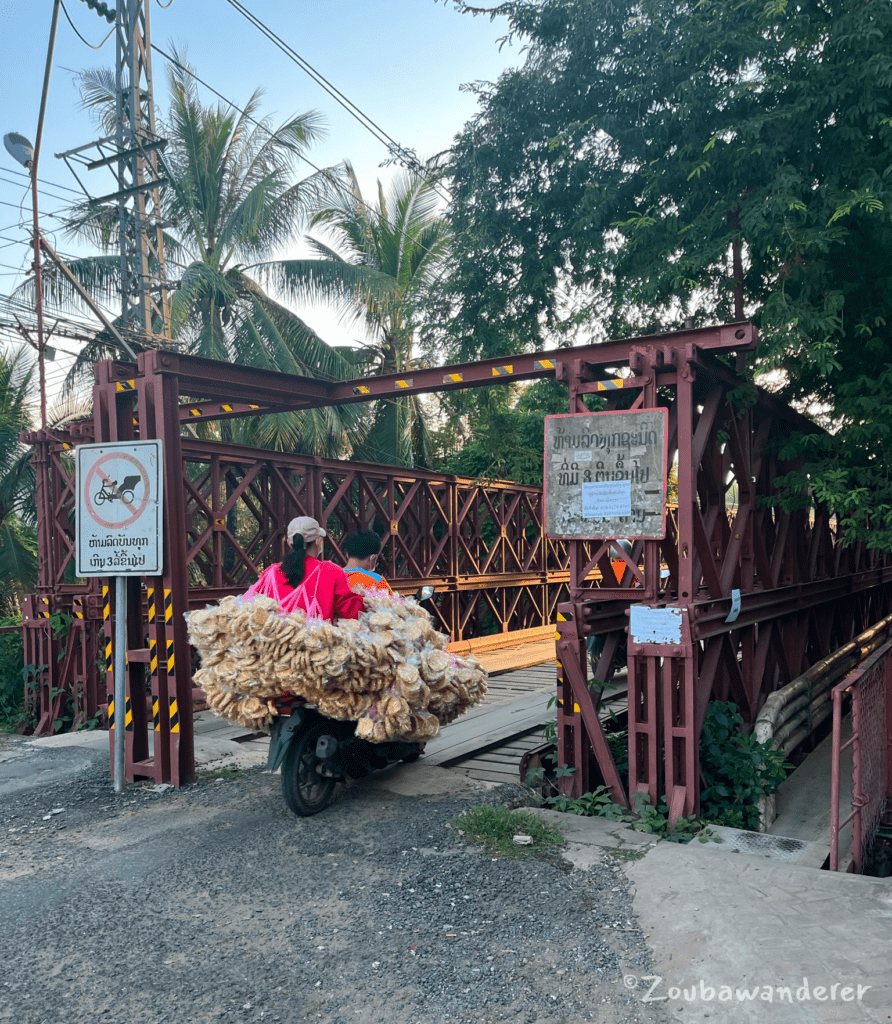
[[538, 811, 892, 1024]]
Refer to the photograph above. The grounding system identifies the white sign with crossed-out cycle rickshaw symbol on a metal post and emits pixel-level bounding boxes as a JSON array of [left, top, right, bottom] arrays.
[[75, 440, 164, 577]]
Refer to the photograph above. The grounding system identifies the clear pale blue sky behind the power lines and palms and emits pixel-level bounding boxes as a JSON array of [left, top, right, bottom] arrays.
[[0, 0, 522, 380]]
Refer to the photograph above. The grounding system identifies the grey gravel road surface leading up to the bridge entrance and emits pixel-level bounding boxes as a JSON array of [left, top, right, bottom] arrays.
[[0, 750, 668, 1024]]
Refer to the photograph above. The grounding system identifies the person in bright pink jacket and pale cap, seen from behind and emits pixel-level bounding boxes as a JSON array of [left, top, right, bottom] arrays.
[[245, 515, 365, 623]]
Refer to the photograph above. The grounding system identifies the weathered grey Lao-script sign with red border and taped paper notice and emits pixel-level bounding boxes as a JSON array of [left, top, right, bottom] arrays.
[[544, 409, 668, 540]]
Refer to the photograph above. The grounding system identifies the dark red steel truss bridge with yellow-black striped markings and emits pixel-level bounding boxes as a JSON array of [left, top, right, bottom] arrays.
[[24, 323, 892, 802]]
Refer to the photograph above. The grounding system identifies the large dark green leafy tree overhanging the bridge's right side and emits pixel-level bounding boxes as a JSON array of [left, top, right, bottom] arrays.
[[440, 0, 892, 550]]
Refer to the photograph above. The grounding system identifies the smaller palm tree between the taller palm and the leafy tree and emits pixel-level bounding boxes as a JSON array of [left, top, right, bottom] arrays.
[[262, 162, 450, 466]]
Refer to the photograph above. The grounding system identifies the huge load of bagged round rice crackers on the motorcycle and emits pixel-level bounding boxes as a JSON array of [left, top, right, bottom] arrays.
[[187, 591, 486, 742]]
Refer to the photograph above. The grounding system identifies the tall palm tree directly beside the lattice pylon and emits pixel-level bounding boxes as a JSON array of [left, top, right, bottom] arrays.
[[41, 60, 370, 456]]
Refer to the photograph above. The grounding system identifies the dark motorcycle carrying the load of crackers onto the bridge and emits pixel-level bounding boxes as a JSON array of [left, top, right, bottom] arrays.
[[266, 587, 433, 818]]
